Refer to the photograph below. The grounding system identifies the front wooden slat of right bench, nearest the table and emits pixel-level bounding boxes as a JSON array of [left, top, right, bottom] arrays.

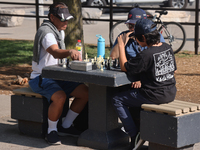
[[142, 104, 182, 116]]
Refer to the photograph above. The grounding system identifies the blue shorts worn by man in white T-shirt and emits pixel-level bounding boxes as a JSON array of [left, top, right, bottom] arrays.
[[29, 76, 82, 102]]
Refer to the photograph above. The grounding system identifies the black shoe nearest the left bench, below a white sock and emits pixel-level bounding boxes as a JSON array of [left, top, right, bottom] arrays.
[[45, 131, 61, 145]]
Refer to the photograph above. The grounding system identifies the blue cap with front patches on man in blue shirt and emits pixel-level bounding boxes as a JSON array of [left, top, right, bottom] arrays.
[[126, 8, 147, 24]]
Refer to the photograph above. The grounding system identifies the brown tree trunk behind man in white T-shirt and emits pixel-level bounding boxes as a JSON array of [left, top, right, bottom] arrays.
[[53, 0, 85, 59]]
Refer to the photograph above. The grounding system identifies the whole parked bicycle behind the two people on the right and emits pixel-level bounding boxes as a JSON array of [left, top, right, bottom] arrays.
[[109, 10, 186, 53]]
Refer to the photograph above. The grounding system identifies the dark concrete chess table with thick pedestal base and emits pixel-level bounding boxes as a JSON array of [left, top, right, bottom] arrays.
[[42, 66, 131, 149]]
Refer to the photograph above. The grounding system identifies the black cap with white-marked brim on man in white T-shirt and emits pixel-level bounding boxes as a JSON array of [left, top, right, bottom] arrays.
[[52, 7, 74, 21]]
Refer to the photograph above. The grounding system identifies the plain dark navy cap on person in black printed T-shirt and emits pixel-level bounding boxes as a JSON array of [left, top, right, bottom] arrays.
[[134, 19, 157, 35]]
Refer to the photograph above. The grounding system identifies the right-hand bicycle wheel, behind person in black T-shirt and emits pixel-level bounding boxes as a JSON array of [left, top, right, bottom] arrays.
[[159, 22, 186, 54]]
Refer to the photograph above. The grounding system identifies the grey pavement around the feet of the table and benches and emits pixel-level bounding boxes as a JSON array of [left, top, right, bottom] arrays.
[[0, 95, 200, 150]]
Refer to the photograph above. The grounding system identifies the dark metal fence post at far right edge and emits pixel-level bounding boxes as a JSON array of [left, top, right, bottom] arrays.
[[194, 0, 199, 54]]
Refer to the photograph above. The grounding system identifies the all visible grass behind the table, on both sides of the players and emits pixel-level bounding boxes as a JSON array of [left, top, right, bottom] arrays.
[[0, 40, 197, 67]]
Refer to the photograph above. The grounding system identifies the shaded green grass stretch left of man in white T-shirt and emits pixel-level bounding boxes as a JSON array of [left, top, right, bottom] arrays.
[[0, 40, 33, 66]]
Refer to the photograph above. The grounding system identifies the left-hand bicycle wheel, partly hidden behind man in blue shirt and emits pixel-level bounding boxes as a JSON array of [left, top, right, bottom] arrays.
[[109, 20, 128, 45]]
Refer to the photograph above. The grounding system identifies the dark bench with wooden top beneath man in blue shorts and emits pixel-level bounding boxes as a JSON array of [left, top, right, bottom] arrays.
[[11, 88, 49, 137]]
